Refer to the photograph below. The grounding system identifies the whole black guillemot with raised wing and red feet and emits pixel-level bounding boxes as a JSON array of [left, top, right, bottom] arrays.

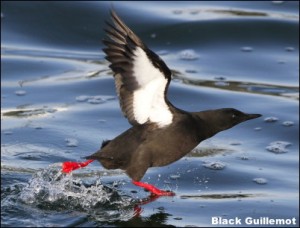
[[63, 10, 261, 196]]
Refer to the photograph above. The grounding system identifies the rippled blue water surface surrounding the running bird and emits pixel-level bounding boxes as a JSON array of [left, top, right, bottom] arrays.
[[1, 1, 299, 227]]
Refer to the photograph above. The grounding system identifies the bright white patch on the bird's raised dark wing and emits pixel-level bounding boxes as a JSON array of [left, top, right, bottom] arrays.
[[133, 47, 173, 127]]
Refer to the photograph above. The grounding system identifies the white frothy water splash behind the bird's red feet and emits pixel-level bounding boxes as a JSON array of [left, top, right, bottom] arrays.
[[19, 166, 130, 211]]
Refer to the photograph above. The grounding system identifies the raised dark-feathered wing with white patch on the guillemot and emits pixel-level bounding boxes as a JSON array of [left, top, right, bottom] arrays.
[[103, 11, 173, 127]]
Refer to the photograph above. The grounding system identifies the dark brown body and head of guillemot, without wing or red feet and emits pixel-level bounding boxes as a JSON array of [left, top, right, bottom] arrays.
[[88, 109, 258, 181]]
